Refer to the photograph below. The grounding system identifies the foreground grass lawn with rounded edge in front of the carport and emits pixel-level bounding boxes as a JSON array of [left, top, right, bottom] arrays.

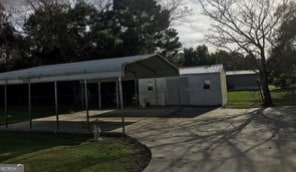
[[0, 132, 135, 172]]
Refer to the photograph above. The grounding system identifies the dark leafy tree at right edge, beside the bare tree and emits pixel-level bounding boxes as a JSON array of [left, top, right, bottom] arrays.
[[267, 1, 296, 88]]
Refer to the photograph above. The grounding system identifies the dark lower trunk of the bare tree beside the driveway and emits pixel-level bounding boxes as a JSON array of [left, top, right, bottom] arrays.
[[260, 51, 272, 106]]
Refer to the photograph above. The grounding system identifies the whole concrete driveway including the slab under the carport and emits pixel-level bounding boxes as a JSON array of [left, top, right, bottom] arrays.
[[1, 107, 296, 172]]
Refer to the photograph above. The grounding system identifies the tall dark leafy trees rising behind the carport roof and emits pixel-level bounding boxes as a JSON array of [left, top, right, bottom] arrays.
[[0, 0, 186, 71]]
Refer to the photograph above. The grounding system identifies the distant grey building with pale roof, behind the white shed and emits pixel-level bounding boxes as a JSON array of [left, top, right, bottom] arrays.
[[226, 70, 260, 90]]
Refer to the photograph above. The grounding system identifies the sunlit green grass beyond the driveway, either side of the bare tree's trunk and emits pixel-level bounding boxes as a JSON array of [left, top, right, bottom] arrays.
[[226, 86, 296, 109]]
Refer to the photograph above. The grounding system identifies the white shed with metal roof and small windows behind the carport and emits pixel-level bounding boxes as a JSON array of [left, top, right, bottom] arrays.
[[139, 65, 227, 107]]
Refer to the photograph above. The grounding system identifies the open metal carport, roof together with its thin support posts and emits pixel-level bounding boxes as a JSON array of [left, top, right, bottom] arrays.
[[0, 54, 178, 133]]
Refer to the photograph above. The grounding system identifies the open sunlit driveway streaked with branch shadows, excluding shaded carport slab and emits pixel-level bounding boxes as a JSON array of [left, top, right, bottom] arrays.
[[130, 107, 296, 172]]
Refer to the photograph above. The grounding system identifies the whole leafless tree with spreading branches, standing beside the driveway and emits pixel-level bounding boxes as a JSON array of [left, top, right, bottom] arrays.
[[199, 0, 286, 106]]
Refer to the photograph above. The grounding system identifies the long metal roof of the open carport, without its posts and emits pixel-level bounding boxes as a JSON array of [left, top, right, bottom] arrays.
[[0, 54, 178, 84]]
